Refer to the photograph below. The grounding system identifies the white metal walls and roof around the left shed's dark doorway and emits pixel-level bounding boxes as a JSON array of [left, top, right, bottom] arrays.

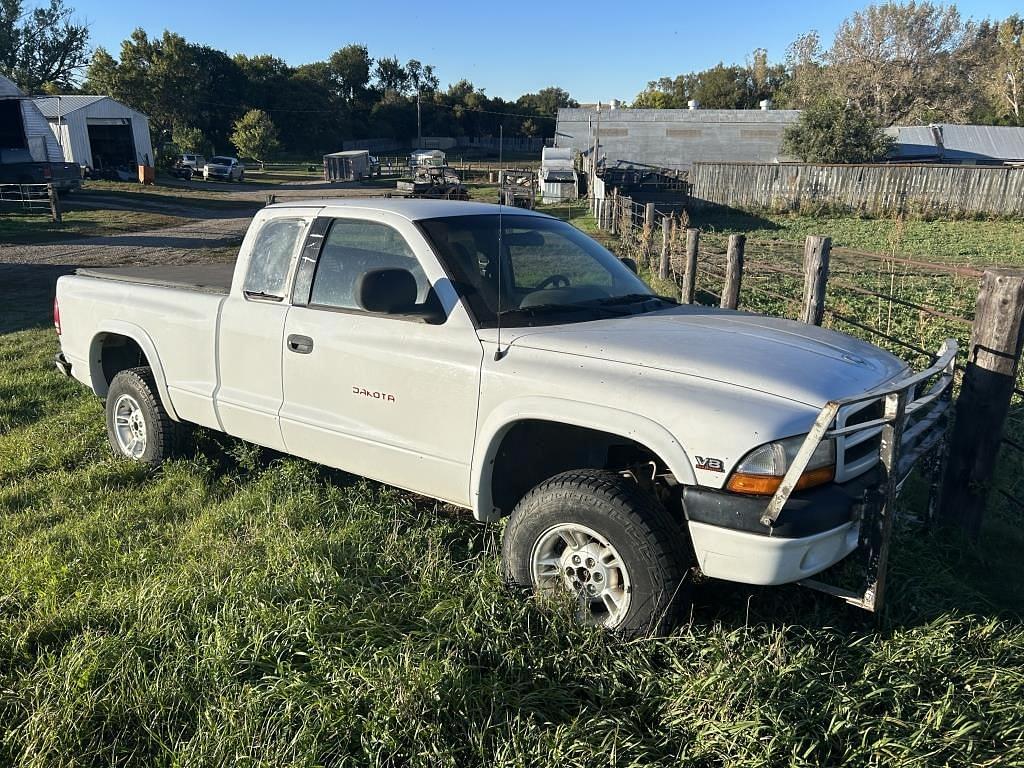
[[35, 94, 156, 168]]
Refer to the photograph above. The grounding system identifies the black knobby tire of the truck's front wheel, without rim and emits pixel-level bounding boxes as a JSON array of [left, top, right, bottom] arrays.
[[502, 470, 692, 637]]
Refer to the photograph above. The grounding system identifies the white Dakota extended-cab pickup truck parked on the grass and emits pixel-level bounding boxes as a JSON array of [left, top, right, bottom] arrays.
[[54, 199, 955, 632]]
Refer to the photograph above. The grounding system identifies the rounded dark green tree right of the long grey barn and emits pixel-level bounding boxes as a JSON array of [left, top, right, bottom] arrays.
[[782, 98, 893, 163]]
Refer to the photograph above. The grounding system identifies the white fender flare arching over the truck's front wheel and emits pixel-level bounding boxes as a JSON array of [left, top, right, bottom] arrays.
[[470, 396, 696, 521]]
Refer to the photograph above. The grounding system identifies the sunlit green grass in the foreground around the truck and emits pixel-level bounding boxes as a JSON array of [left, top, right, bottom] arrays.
[[0, 208, 1024, 768]]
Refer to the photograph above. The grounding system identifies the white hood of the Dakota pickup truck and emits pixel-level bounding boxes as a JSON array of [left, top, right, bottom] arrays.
[[488, 306, 907, 408]]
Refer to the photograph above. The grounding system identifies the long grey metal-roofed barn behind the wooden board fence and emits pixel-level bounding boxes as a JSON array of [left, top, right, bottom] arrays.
[[555, 109, 800, 170]]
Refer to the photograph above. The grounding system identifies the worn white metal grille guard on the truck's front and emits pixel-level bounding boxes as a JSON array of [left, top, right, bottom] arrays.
[[761, 339, 957, 611]]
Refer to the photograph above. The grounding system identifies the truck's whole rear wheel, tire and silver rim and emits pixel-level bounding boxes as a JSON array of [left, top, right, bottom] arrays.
[[106, 368, 184, 466]]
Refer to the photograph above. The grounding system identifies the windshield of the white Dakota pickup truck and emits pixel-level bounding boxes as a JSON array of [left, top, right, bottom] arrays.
[[419, 214, 672, 328]]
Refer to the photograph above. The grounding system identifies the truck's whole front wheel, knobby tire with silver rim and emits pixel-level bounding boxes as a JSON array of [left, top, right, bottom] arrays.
[[502, 470, 690, 635]]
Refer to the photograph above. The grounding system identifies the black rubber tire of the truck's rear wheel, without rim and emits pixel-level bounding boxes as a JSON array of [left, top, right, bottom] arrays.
[[106, 367, 186, 467]]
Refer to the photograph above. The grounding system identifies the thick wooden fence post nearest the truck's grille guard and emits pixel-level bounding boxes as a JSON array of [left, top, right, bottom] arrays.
[[939, 269, 1024, 537]]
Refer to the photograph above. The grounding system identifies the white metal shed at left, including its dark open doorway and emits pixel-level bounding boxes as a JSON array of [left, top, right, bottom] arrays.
[[35, 95, 156, 172]]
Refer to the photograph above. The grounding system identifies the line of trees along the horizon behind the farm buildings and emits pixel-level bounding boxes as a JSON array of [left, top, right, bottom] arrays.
[[6, 0, 1024, 162]]
